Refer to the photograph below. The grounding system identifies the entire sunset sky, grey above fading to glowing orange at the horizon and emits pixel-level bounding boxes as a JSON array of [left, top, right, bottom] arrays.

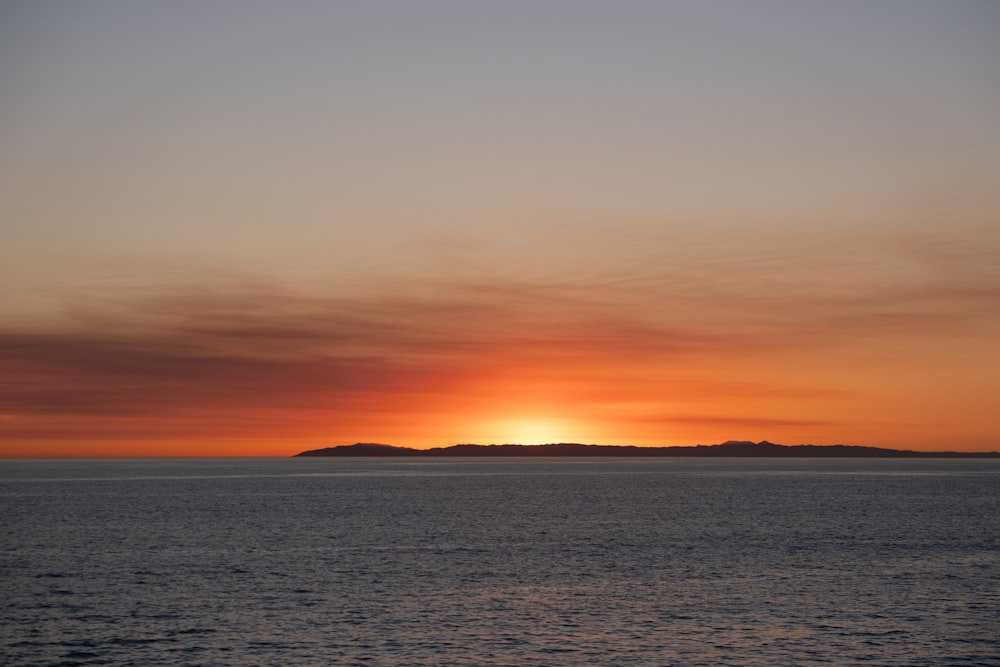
[[0, 0, 1000, 457]]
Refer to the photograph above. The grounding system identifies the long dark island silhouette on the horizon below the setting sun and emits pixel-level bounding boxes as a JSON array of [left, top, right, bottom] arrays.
[[295, 440, 1000, 459]]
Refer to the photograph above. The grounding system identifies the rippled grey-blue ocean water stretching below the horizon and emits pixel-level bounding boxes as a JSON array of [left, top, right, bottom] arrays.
[[0, 458, 1000, 667]]
